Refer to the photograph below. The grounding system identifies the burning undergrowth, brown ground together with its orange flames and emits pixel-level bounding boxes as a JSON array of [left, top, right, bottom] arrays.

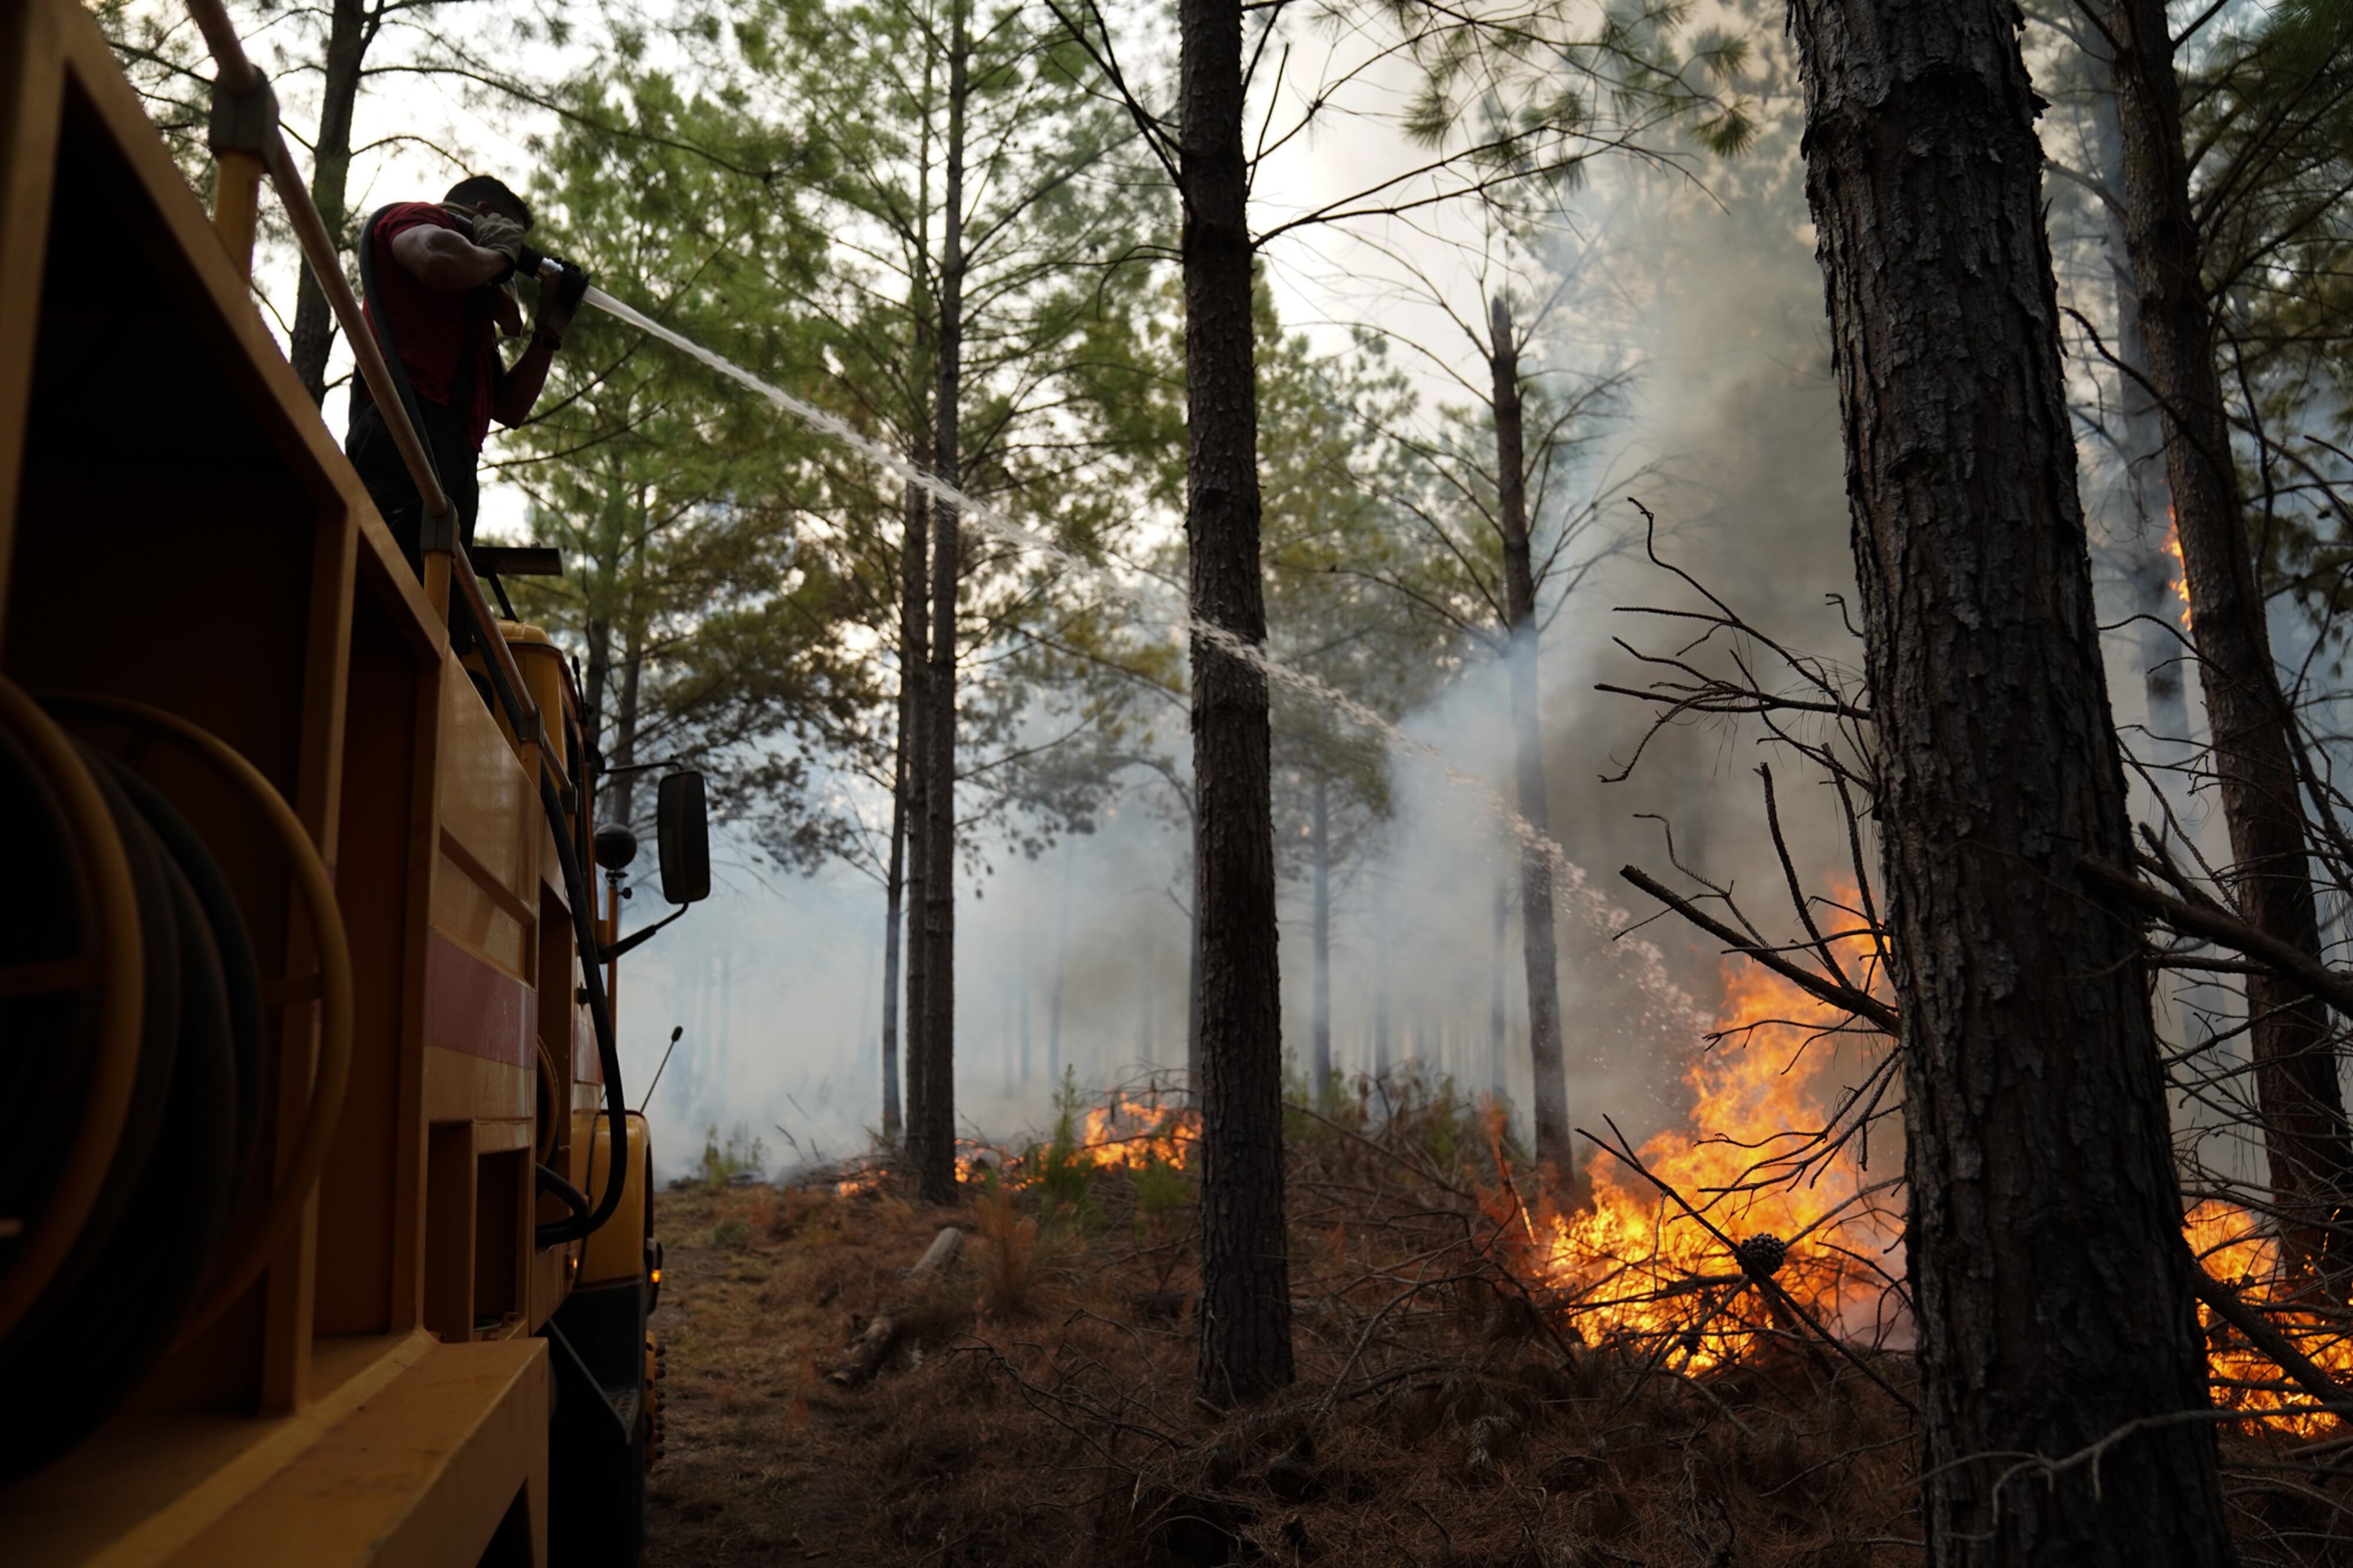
[[652, 968, 2348, 1568]]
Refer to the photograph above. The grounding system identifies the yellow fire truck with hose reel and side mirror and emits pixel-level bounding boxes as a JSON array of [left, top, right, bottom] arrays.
[[0, 0, 711, 1568]]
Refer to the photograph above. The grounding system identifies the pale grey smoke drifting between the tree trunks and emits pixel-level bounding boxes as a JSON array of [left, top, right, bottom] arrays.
[[621, 61, 1892, 1172]]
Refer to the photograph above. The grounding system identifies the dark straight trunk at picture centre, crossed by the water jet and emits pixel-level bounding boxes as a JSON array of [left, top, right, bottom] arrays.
[[1176, 0, 1292, 1408]]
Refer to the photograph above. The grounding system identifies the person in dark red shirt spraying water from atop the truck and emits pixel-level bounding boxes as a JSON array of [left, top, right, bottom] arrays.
[[344, 174, 588, 577]]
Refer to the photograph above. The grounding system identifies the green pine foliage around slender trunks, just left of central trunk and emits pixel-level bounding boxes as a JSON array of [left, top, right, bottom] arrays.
[[736, 0, 1169, 855]]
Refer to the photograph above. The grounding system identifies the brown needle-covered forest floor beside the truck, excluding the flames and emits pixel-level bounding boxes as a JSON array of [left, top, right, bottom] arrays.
[[647, 1087, 1920, 1568]]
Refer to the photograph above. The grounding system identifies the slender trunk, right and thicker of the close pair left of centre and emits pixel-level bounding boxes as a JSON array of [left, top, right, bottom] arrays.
[[908, 0, 969, 1203]]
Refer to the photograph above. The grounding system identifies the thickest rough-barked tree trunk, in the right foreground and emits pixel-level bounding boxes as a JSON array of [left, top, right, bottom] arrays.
[[1791, 0, 2235, 1568]]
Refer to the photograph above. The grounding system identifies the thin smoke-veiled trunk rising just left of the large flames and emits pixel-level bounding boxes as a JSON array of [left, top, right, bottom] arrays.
[[1487, 296, 1577, 1180]]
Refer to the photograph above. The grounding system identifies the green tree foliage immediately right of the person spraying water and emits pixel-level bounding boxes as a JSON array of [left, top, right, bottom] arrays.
[[501, 71, 875, 864]]
